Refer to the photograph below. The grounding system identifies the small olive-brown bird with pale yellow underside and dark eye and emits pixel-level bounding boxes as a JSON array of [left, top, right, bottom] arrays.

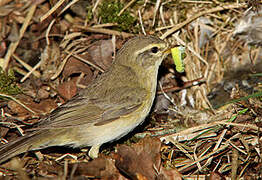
[[0, 36, 170, 163]]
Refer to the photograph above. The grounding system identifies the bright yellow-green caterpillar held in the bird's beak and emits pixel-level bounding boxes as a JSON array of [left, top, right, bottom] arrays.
[[171, 46, 186, 73]]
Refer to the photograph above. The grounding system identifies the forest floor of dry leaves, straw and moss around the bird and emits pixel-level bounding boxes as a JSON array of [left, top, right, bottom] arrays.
[[0, 0, 262, 180]]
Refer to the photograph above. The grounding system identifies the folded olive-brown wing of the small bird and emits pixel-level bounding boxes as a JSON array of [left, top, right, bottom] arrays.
[[36, 87, 147, 129]]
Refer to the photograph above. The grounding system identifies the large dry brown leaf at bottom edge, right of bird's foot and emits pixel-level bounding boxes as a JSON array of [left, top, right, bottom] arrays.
[[116, 138, 161, 179]]
